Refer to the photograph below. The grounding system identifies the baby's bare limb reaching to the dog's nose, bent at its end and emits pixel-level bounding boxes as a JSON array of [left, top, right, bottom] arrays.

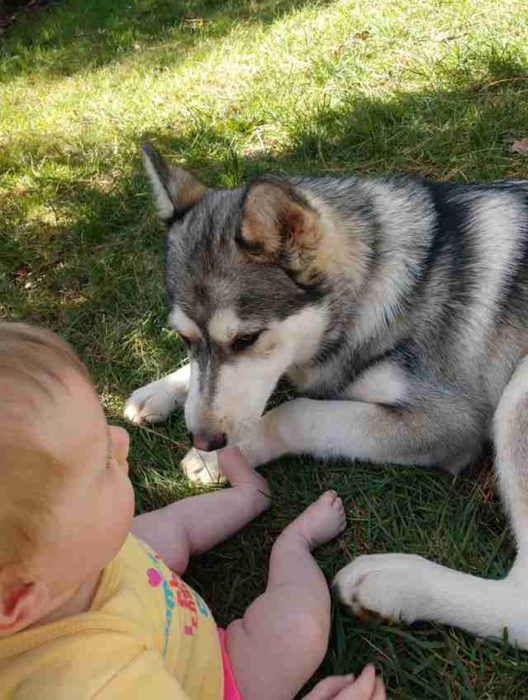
[[132, 448, 269, 574]]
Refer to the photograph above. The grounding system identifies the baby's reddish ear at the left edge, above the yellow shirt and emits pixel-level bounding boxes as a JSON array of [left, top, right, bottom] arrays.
[[0, 567, 50, 637]]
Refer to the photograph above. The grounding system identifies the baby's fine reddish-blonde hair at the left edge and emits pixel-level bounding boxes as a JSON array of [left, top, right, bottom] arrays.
[[0, 323, 88, 568]]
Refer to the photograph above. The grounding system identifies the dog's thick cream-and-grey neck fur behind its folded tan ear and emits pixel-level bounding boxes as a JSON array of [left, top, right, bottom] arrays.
[[291, 181, 428, 395]]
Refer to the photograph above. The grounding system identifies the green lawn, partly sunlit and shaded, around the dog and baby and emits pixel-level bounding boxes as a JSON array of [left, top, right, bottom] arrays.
[[0, 0, 528, 699]]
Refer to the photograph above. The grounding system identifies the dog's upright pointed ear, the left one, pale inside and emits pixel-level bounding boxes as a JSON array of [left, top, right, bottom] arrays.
[[141, 143, 207, 222]]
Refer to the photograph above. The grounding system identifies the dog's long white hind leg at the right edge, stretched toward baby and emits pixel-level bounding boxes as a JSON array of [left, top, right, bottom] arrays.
[[335, 359, 528, 649]]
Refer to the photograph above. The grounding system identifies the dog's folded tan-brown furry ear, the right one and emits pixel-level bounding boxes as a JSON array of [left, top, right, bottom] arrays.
[[239, 180, 321, 272]]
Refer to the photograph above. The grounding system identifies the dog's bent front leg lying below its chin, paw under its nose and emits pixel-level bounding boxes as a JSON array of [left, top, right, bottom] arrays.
[[182, 399, 472, 483]]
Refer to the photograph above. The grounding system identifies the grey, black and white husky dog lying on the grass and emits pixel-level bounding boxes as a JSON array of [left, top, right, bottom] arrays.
[[125, 146, 528, 649]]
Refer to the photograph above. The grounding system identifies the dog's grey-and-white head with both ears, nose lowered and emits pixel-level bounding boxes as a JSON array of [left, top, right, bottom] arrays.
[[143, 145, 326, 449]]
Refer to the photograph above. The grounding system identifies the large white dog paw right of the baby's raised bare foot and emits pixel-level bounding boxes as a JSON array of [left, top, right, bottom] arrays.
[[333, 554, 443, 623]]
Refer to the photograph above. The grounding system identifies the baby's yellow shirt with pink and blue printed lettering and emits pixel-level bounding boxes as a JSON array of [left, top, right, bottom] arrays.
[[0, 535, 223, 700]]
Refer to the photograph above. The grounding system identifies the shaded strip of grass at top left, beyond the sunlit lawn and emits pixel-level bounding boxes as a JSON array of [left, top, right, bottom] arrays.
[[0, 0, 323, 81]]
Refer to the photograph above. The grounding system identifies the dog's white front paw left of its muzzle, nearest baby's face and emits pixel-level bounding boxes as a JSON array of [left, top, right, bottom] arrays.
[[124, 364, 191, 423]]
